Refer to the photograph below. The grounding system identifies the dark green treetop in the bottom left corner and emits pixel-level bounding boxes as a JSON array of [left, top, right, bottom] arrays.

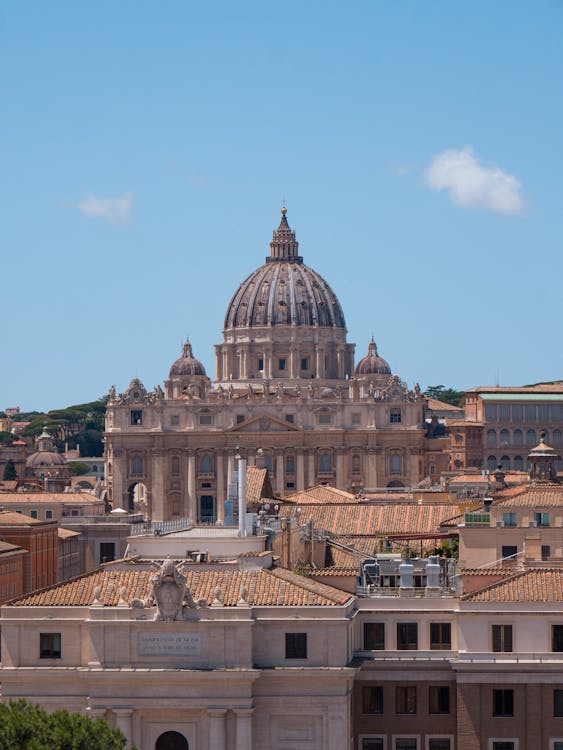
[[0, 700, 133, 750]]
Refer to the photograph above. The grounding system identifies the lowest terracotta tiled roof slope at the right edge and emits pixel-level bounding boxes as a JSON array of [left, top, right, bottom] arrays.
[[461, 568, 563, 603]]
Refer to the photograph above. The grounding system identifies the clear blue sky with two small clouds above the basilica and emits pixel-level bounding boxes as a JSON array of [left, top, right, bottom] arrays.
[[0, 0, 563, 410]]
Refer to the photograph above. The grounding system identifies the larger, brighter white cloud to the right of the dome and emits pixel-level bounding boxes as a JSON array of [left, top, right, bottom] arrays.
[[425, 146, 524, 214]]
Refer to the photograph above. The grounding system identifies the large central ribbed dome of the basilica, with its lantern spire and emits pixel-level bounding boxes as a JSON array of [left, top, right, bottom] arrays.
[[225, 209, 346, 329]]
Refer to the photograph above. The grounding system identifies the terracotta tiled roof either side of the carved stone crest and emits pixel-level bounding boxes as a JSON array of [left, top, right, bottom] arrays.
[[9, 566, 350, 607]]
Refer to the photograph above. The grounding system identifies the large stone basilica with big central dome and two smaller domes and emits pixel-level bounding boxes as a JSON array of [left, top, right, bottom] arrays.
[[106, 209, 425, 523]]
